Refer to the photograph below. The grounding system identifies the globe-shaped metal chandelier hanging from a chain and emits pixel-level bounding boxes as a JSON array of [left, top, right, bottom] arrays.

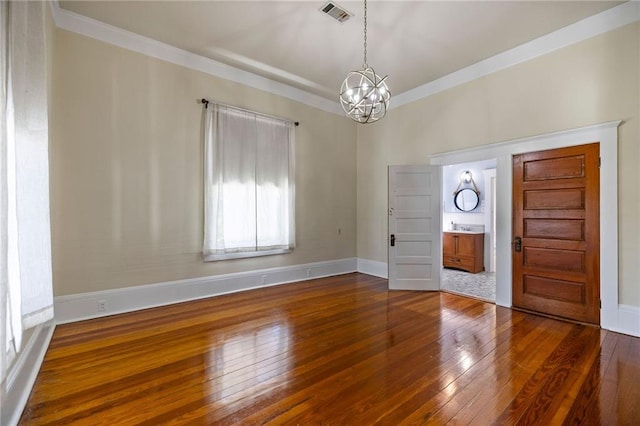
[[340, 0, 391, 123]]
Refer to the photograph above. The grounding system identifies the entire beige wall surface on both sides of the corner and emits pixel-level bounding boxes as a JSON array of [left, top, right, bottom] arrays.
[[50, 23, 640, 306]]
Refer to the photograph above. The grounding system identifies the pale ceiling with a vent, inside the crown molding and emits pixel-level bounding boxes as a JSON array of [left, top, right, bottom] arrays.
[[60, 0, 622, 100]]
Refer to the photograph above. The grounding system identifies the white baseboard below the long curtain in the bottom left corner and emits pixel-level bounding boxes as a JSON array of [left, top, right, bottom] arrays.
[[0, 320, 56, 425]]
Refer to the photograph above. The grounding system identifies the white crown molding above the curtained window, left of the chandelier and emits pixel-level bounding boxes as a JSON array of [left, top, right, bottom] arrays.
[[51, 1, 344, 115]]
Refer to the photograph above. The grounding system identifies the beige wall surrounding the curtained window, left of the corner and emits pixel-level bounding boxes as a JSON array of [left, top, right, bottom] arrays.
[[50, 30, 356, 296]]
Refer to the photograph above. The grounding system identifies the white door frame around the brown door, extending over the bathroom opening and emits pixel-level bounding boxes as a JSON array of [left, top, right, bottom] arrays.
[[429, 121, 621, 331]]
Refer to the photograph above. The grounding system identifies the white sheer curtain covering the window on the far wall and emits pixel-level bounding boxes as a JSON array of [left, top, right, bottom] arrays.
[[203, 103, 295, 260]]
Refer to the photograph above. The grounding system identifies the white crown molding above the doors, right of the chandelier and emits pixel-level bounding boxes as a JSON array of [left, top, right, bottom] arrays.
[[392, 1, 640, 108]]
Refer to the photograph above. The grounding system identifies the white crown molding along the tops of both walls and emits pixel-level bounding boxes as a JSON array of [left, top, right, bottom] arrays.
[[51, 0, 640, 115]]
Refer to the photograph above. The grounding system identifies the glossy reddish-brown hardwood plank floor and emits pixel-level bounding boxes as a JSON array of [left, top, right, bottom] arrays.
[[21, 274, 640, 425]]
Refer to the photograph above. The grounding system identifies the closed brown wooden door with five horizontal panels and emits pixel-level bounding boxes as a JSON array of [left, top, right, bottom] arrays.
[[512, 143, 600, 324]]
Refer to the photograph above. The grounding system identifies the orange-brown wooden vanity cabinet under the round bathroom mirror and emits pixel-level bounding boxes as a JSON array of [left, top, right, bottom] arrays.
[[442, 232, 484, 274]]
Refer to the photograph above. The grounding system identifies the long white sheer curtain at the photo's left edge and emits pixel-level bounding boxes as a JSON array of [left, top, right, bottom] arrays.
[[0, 1, 53, 380]]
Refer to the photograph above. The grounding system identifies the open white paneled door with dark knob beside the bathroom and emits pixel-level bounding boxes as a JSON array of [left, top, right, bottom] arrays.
[[388, 166, 442, 290]]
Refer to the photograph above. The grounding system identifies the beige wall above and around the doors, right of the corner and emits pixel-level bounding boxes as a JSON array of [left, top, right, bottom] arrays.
[[357, 23, 640, 306]]
